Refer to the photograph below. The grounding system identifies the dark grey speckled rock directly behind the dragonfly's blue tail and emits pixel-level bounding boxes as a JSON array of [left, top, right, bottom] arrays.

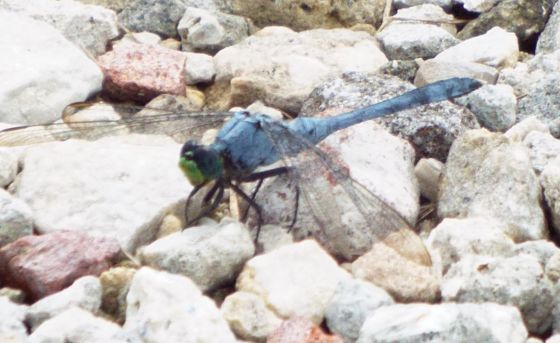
[[301, 73, 478, 161]]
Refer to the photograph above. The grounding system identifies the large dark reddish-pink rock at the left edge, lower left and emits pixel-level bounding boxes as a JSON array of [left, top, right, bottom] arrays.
[[0, 231, 120, 300]]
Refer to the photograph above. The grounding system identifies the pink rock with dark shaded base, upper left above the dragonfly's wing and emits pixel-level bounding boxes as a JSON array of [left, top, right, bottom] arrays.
[[97, 43, 187, 102]]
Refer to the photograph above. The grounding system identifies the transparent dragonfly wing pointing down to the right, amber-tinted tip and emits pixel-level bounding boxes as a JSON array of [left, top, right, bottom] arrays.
[[263, 122, 431, 266]]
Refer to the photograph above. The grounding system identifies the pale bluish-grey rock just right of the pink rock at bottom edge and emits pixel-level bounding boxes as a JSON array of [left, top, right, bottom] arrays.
[[325, 279, 393, 342]]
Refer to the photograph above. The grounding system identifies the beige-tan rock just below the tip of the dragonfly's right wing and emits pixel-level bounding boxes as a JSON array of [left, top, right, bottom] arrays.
[[352, 244, 440, 302]]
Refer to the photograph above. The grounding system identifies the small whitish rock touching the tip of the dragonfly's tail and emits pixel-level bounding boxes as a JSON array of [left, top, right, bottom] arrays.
[[467, 85, 517, 131]]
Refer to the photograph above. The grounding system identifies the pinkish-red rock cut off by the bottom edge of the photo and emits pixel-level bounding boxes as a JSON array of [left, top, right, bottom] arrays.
[[266, 317, 343, 343]]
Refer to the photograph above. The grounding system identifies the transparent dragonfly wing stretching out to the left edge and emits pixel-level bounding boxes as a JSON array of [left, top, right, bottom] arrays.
[[0, 102, 231, 146]]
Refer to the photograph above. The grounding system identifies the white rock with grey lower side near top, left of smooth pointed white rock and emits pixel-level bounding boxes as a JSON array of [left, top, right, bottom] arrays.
[[377, 21, 460, 60]]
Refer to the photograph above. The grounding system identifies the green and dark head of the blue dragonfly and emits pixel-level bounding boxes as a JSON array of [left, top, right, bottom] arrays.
[[179, 141, 223, 186]]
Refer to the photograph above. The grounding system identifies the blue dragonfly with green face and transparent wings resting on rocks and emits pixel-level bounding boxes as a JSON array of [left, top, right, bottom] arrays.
[[0, 78, 482, 266]]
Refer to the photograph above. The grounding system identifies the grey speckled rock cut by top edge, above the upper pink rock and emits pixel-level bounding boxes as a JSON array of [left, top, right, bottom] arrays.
[[119, 0, 187, 37]]
